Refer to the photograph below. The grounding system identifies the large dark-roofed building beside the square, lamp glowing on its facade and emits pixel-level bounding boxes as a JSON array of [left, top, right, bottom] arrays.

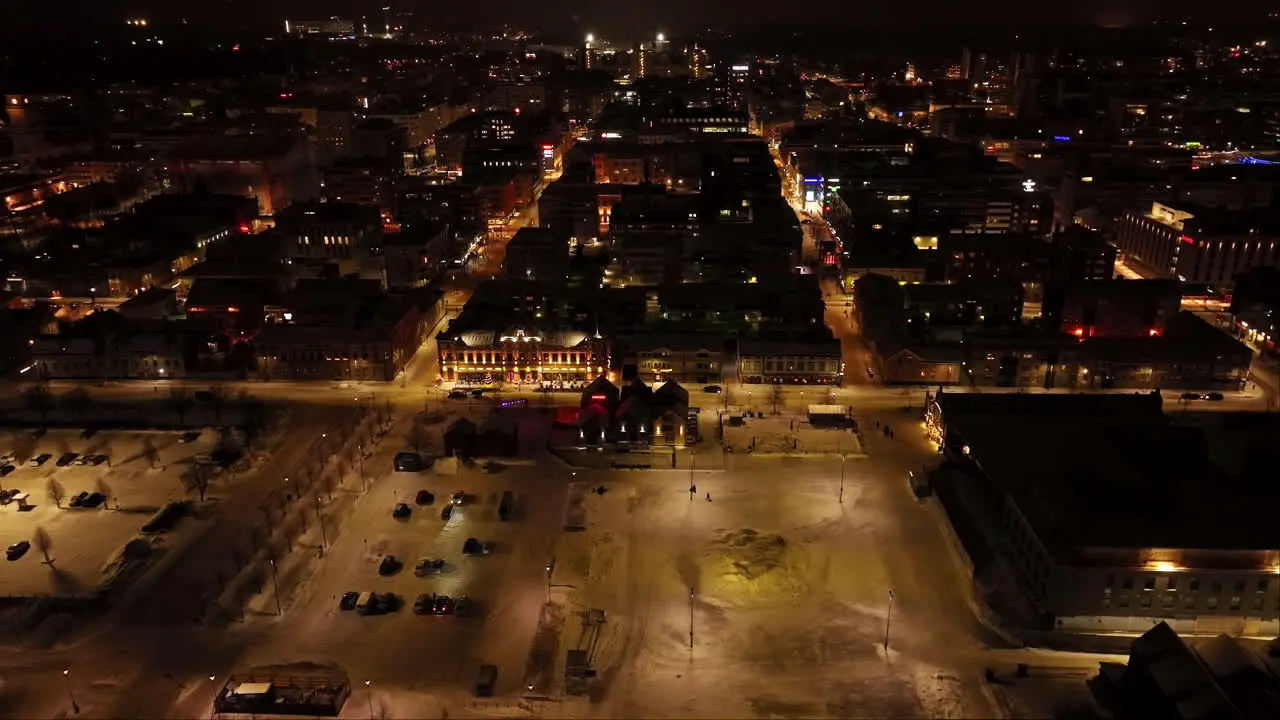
[[925, 392, 1280, 637]]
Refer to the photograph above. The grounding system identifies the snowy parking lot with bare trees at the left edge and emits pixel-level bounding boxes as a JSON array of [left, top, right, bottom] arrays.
[[0, 430, 212, 597]]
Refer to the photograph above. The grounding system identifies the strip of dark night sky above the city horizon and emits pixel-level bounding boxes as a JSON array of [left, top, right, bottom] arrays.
[[6, 0, 1262, 36]]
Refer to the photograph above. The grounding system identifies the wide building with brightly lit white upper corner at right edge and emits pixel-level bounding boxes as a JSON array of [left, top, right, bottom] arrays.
[[1112, 202, 1280, 287]]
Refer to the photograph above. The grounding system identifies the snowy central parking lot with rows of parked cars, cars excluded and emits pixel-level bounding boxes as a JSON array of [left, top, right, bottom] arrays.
[[239, 442, 568, 696]]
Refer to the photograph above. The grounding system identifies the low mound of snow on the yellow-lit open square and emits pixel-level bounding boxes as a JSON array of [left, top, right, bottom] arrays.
[[701, 528, 808, 606]]
